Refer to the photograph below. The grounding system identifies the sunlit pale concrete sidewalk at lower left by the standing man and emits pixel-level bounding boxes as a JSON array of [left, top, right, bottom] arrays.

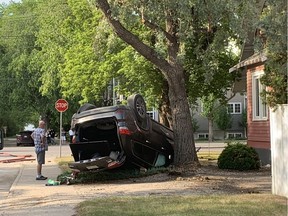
[[0, 147, 83, 216]]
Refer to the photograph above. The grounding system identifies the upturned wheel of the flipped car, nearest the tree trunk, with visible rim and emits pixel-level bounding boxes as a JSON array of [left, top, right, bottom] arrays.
[[127, 94, 147, 122]]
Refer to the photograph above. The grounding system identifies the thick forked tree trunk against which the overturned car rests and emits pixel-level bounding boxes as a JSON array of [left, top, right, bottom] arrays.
[[96, 0, 198, 165]]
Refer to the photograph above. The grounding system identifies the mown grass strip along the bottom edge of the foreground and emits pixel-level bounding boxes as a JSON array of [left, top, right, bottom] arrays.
[[76, 194, 287, 216]]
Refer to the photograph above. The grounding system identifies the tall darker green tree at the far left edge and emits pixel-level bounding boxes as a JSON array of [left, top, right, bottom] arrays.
[[0, 0, 75, 133]]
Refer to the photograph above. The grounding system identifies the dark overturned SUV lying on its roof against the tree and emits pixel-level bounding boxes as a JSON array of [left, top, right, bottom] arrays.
[[69, 94, 174, 171]]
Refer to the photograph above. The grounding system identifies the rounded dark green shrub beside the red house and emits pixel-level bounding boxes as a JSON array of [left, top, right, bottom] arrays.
[[217, 142, 260, 170]]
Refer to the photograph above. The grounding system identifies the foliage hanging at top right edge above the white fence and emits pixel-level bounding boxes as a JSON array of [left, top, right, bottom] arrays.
[[256, 0, 288, 108]]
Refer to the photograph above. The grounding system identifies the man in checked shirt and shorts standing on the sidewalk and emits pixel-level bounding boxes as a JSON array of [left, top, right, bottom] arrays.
[[31, 120, 47, 180]]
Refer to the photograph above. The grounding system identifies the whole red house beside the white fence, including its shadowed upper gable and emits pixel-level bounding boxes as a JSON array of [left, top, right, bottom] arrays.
[[229, 0, 271, 165]]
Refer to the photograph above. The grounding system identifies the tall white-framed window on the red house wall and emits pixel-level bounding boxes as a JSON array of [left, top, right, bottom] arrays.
[[252, 72, 267, 120]]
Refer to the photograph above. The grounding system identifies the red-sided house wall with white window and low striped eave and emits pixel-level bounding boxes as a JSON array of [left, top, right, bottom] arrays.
[[230, 53, 271, 164]]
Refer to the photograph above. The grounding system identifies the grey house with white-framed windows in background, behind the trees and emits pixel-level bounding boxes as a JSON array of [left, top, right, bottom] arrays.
[[193, 93, 246, 140]]
